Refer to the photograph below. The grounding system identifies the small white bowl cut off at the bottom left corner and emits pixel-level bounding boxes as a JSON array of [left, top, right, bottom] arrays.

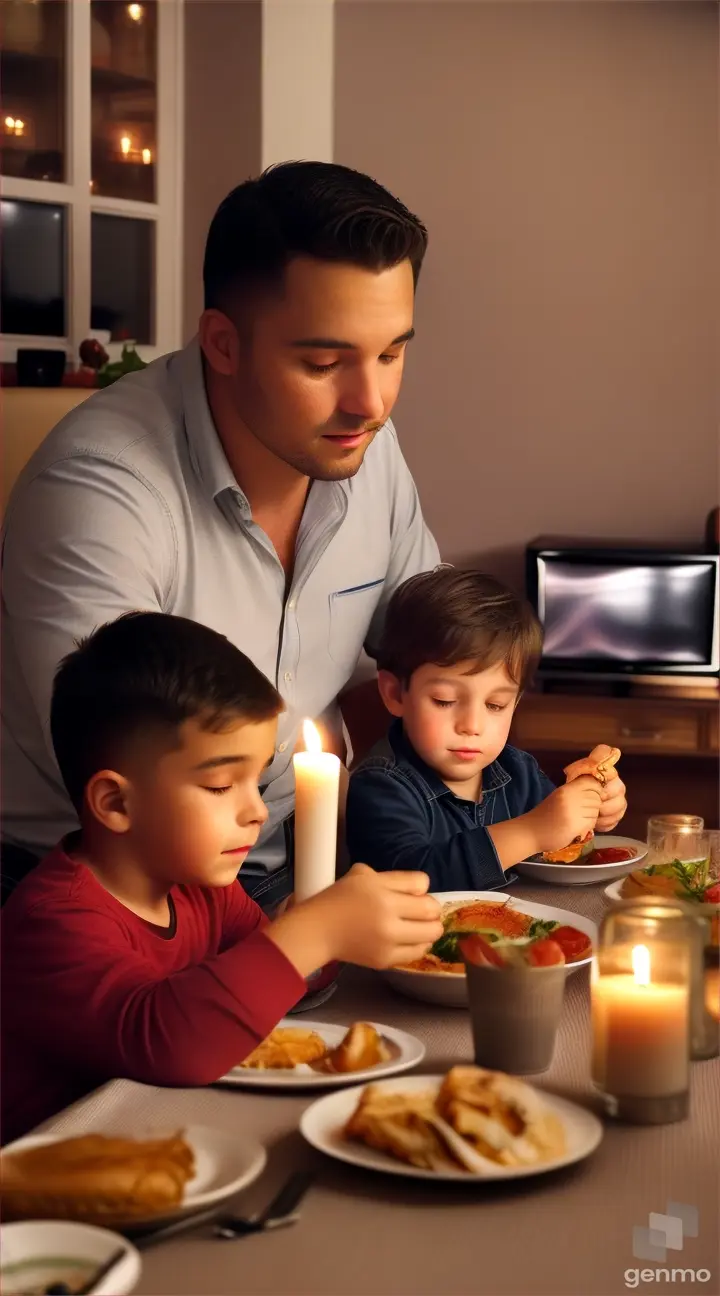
[[0, 1220, 141, 1296]]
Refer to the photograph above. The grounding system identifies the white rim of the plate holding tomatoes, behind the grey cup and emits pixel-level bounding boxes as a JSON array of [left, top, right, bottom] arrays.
[[381, 890, 597, 1008]]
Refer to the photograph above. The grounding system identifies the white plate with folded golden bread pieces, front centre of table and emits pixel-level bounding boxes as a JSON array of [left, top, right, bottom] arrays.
[[300, 1067, 603, 1183]]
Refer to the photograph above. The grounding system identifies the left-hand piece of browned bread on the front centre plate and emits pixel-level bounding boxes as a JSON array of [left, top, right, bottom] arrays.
[[344, 1085, 460, 1170]]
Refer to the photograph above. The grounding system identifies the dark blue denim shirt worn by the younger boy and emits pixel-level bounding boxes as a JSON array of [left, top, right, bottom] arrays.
[[347, 721, 554, 890]]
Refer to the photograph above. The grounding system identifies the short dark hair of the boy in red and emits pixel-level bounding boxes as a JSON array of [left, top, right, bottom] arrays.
[[51, 612, 284, 811]]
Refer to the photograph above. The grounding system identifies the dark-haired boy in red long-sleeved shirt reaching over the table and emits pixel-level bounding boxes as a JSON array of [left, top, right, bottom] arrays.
[[1, 613, 442, 1142]]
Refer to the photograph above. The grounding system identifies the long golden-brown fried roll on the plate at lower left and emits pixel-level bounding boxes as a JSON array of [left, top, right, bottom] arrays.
[[0, 1134, 194, 1225]]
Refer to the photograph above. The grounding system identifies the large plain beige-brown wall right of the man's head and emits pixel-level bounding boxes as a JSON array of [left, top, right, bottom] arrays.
[[335, 0, 720, 588]]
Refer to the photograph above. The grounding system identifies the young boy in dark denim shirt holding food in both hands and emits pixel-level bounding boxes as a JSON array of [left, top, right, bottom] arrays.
[[347, 566, 627, 890]]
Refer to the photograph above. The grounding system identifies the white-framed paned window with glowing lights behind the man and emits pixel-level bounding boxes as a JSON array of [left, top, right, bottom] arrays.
[[0, 0, 183, 363]]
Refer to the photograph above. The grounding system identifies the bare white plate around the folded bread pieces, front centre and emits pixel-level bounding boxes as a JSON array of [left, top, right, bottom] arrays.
[[300, 1076, 603, 1183]]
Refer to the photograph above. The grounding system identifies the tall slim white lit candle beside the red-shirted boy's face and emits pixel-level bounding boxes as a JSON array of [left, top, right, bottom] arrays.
[[293, 721, 341, 899]]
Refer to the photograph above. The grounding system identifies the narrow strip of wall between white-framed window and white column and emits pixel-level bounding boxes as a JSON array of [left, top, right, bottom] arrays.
[[183, 0, 262, 340]]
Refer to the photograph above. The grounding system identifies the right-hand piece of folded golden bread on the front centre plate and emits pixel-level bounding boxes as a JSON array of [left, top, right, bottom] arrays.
[[436, 1067, 566, 1165]]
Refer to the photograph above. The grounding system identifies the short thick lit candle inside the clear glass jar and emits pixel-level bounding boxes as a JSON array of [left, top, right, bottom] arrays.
[[592, 945, 689, 1098]]
